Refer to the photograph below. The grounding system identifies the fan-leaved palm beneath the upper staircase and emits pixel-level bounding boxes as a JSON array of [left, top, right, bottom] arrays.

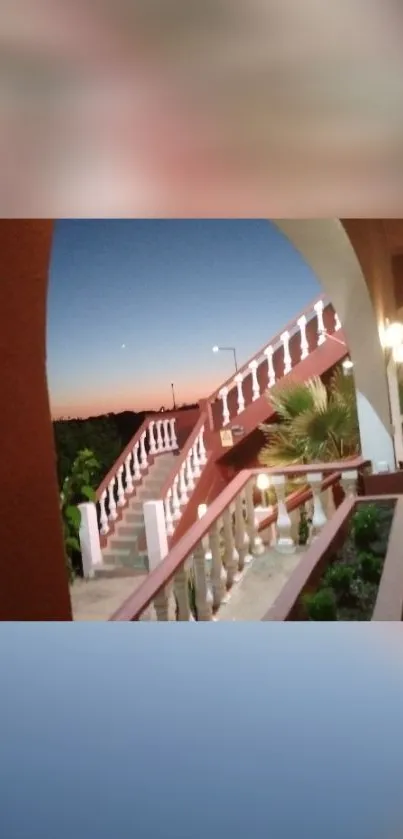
[[259, 367, 360, 466]]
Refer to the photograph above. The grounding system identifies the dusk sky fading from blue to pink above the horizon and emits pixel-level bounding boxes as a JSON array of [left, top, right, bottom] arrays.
[[47, 220, 321, 416]]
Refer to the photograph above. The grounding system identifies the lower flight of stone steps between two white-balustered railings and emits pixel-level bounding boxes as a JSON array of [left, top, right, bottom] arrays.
[[95, 452, 175, 577]]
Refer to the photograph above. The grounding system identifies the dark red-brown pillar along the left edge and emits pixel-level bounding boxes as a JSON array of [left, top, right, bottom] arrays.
[[0, 220, 72, 621]]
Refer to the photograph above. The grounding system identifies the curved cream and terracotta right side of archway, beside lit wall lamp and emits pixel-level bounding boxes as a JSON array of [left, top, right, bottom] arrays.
[[275, 219, 396, 470]]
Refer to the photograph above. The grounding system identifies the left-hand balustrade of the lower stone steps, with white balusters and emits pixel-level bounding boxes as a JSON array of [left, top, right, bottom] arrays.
[[96, 414, 178, 536]]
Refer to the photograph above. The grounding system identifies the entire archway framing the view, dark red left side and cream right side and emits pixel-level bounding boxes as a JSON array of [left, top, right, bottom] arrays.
[[0, 219, 400, 621]]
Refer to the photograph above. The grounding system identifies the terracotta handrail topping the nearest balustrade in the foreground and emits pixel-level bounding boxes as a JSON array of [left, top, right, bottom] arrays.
[[110, 457, 369, 621]]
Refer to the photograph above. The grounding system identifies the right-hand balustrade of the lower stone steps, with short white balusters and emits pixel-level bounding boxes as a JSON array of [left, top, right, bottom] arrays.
[[161, 411, 208, 536]]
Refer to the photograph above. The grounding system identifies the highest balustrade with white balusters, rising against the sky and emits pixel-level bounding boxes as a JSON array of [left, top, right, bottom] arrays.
[[210, 298, 347, 428]]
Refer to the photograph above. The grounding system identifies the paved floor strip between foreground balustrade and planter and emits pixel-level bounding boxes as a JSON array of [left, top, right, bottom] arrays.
[[216, 548, 305, 621]]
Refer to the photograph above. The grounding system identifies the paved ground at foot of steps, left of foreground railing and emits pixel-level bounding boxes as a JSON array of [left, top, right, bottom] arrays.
[[70, 574, 147, 621]]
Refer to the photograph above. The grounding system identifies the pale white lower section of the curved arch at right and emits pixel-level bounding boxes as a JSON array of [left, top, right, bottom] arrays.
[[356, 390, 396, 472]]
